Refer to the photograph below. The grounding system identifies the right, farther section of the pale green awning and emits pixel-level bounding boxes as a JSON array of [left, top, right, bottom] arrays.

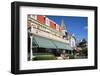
[[52, 40, 73, 50]]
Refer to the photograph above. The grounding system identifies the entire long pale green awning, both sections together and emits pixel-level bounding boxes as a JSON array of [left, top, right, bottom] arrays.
[[33, 35, 73, 50]]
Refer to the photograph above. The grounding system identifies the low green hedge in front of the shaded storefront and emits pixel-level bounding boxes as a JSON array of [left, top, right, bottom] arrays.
[[32, 55, 56, 60]]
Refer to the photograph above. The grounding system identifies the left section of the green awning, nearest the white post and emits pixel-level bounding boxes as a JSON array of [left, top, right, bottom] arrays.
[[33, 35, 57, 49]]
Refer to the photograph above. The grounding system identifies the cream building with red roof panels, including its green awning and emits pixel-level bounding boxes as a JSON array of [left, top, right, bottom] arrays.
[[28, 15, 73, 60]]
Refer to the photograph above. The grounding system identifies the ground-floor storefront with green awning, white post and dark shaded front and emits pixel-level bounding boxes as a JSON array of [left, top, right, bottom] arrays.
[[29, 35, 73, 58]]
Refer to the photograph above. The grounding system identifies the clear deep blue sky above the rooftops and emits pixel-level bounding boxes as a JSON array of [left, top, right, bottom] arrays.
[[47, 16, 88, 40]]
